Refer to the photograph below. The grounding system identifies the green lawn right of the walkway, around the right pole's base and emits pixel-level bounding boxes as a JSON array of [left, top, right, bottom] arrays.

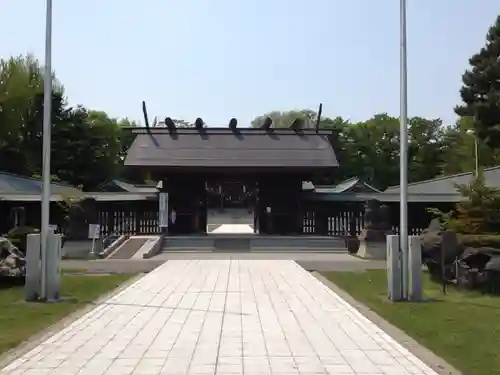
[[325, 270, 500, 375]]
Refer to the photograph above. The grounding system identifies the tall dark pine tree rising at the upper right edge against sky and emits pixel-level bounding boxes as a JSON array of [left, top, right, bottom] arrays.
[[455, 16, 500, 147]]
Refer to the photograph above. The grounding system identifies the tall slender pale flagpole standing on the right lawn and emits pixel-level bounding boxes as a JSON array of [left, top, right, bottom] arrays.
[[399, 0, 408, 299]]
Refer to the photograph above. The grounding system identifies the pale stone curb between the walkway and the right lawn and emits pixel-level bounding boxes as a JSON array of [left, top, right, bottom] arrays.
[[311, 272, 463, 375]]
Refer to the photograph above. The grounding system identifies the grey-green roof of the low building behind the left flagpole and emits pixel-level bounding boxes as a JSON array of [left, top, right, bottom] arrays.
[[0, 172, 81, 195]]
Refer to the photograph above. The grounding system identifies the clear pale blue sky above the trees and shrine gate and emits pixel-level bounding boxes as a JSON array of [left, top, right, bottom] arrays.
[[0, 0, 500, 126]]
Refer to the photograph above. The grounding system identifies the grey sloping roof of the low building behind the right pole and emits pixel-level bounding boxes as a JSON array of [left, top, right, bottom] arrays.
[[384, 166, 500, 194]]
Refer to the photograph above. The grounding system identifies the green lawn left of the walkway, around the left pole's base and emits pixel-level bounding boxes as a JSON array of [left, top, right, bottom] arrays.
[[0, 275, 132, 355]]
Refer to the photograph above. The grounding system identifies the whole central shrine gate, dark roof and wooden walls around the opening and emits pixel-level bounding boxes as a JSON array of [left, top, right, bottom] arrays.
[[125, 128, 338, 236]]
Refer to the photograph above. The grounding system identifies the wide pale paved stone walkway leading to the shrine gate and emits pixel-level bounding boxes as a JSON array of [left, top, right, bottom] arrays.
[[0, 260, 435, 375]]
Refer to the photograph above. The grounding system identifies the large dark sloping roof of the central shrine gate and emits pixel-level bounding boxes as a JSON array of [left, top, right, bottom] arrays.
[[125, 128, 338, 168]]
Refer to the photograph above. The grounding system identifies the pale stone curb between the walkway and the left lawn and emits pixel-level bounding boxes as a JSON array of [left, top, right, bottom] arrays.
[[0, 273, 146, 371]]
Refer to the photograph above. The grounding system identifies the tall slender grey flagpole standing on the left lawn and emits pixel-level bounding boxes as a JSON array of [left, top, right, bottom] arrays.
[[40, 0, 52, 299]]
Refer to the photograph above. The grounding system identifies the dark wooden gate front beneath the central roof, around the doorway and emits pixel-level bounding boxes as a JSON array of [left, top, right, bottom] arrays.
[[162, 174, 303, 235]]
